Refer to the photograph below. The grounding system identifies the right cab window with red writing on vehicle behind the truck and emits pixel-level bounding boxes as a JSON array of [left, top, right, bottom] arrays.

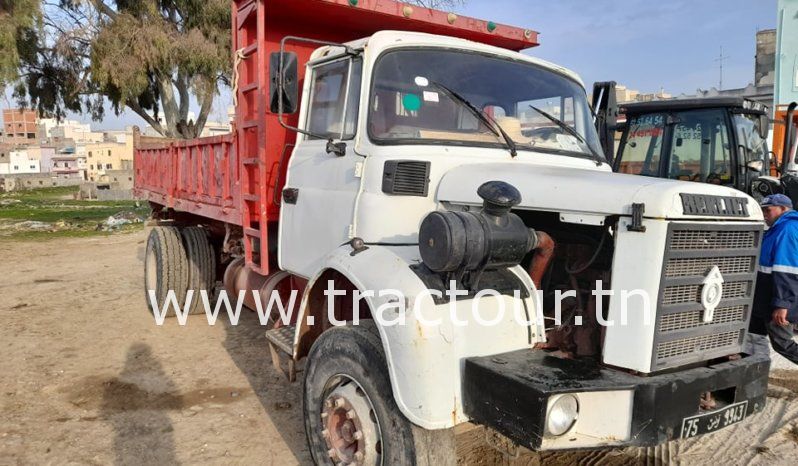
[[668, 110, 734, 184]]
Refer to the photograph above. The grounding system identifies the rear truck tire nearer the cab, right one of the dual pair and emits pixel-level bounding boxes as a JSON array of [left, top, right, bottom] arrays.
[[181, 227, 216, 314]]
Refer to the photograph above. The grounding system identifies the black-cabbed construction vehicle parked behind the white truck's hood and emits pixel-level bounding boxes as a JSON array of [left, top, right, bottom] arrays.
[[593, 81, 798, 206]]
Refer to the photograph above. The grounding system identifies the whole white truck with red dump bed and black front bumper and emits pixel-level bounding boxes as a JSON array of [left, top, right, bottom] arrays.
[[135, 0, 769, 464]]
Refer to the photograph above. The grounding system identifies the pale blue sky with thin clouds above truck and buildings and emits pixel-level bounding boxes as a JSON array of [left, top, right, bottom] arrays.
[[7, 0, 777, 129]]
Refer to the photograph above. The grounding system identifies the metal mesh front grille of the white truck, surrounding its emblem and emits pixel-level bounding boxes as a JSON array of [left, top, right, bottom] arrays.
[[652, 223, 762, 370]]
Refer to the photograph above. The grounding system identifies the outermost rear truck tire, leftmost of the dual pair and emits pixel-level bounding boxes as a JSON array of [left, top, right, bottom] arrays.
[[144, 227, 188, 316]]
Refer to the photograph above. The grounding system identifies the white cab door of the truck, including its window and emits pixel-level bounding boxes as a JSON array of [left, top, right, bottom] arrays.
[[278, 56, 363, 277]]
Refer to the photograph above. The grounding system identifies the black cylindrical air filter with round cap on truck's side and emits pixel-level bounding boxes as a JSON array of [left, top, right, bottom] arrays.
[[418, 181, 538, 285]]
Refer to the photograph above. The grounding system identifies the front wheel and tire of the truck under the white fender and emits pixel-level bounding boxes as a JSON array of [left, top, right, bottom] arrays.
[[302, 321, 455, 466]]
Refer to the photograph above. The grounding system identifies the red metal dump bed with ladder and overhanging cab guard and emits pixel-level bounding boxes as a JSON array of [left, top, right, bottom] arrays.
[[134, 0, 538, 273]]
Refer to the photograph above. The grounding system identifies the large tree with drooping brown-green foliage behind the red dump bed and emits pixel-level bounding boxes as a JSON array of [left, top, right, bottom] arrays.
[[15, 0, 232, 138]]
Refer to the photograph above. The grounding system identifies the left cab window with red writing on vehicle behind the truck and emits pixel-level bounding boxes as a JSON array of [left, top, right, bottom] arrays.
[[618, 114, 665, 176]]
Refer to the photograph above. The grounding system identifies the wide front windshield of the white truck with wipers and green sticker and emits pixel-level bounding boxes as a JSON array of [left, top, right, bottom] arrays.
[[368, 49, 601, 158]]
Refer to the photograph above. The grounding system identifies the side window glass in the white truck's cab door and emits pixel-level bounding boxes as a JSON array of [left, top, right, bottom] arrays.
[[307, 59, 363, 139]]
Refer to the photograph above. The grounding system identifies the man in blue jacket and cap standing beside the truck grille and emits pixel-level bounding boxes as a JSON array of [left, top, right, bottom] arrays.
[[750, 194, 798, 364]]
